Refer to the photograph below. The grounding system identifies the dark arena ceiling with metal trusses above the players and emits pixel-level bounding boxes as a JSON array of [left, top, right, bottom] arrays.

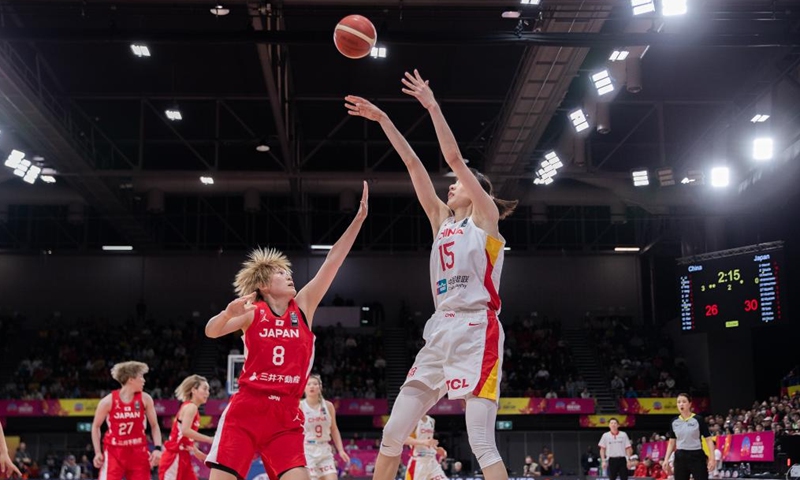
[[0, 0, 800, 252]]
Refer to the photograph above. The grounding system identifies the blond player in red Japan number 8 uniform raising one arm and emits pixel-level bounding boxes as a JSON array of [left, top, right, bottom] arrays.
[[206, 182, 368, 480]]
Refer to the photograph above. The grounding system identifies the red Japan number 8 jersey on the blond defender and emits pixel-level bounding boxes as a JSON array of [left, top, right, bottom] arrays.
[[239, 299, 314, 401]]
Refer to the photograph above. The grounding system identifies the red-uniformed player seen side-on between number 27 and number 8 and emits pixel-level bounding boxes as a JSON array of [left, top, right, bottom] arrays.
[[158, 375, 213, 480]]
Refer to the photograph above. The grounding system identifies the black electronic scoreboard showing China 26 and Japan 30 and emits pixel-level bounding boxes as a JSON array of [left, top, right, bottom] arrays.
[[679, 247, 784, 332]]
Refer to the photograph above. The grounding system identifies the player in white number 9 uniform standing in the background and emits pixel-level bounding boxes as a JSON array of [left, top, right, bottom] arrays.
[[300, 375, 350, 480]]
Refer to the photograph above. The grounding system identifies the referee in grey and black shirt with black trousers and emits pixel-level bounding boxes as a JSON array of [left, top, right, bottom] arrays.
[[664, 393, 716, 480]]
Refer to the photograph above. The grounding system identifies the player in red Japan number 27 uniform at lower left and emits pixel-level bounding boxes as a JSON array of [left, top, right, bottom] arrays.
[[92, 362, 161, 480]]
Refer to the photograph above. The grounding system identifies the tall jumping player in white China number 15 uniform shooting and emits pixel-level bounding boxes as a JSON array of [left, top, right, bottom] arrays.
[[345, 70, 517, 480]]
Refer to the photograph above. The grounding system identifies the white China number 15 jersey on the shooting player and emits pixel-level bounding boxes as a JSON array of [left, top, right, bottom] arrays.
[[430, 217, 506, 312]]
